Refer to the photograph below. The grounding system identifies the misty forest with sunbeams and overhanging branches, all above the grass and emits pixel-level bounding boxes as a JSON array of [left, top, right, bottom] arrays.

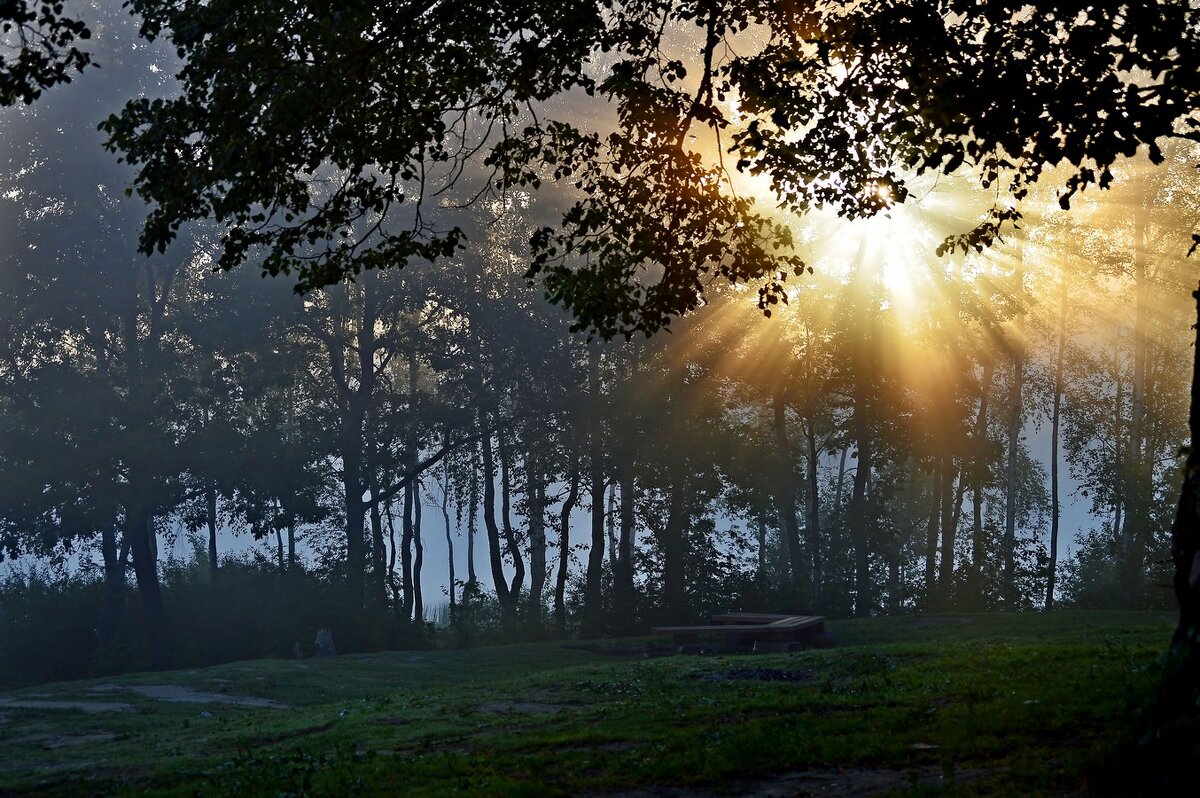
[[0, 0, 1200, 792]]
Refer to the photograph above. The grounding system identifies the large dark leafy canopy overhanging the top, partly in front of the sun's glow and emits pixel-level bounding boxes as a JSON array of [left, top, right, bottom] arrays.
[[104, 0, 1200, 336]]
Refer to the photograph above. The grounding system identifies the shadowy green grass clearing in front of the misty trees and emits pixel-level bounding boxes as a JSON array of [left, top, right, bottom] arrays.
[[0, 612, 1171, 796]]
